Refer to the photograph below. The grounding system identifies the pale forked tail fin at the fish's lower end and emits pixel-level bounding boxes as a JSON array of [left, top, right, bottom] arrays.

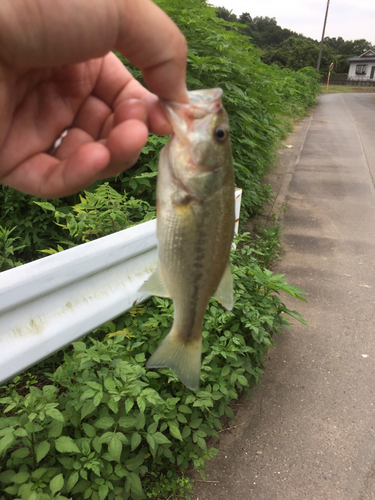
[[146, 328, 202, 391]]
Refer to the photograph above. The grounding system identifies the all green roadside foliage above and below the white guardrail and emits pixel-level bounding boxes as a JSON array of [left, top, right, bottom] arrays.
[[0, 0, 318, 500]]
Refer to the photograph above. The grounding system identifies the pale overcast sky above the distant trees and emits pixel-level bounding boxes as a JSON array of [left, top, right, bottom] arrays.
[[208, 0, 375, 45]]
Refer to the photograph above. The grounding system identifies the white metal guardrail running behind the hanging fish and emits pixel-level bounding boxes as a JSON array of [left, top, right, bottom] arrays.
[[0, 188, 242, 382]]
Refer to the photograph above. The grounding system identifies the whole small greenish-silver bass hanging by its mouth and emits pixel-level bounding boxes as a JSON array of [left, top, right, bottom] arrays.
[[140, 88, 235, 391]]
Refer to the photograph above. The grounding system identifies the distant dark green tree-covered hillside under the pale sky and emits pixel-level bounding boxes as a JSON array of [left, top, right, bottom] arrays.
[[216, 7, 372, 74]]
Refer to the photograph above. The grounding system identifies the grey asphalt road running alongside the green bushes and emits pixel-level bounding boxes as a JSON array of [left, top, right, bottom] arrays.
[[193, 94, 375, 500]]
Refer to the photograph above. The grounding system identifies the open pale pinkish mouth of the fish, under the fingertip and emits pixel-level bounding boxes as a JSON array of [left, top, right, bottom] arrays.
[[161, 88, 223, 139]]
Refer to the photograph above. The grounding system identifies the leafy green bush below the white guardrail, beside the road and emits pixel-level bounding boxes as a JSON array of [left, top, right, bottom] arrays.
[[0, 235, 303, 500]]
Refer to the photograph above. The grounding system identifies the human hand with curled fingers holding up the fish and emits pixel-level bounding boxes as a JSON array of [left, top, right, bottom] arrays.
[[0, 0, 188, 198]]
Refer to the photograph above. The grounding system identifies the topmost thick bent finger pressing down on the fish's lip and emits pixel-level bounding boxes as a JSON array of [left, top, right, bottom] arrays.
[[0, 0, 188, 102]]
